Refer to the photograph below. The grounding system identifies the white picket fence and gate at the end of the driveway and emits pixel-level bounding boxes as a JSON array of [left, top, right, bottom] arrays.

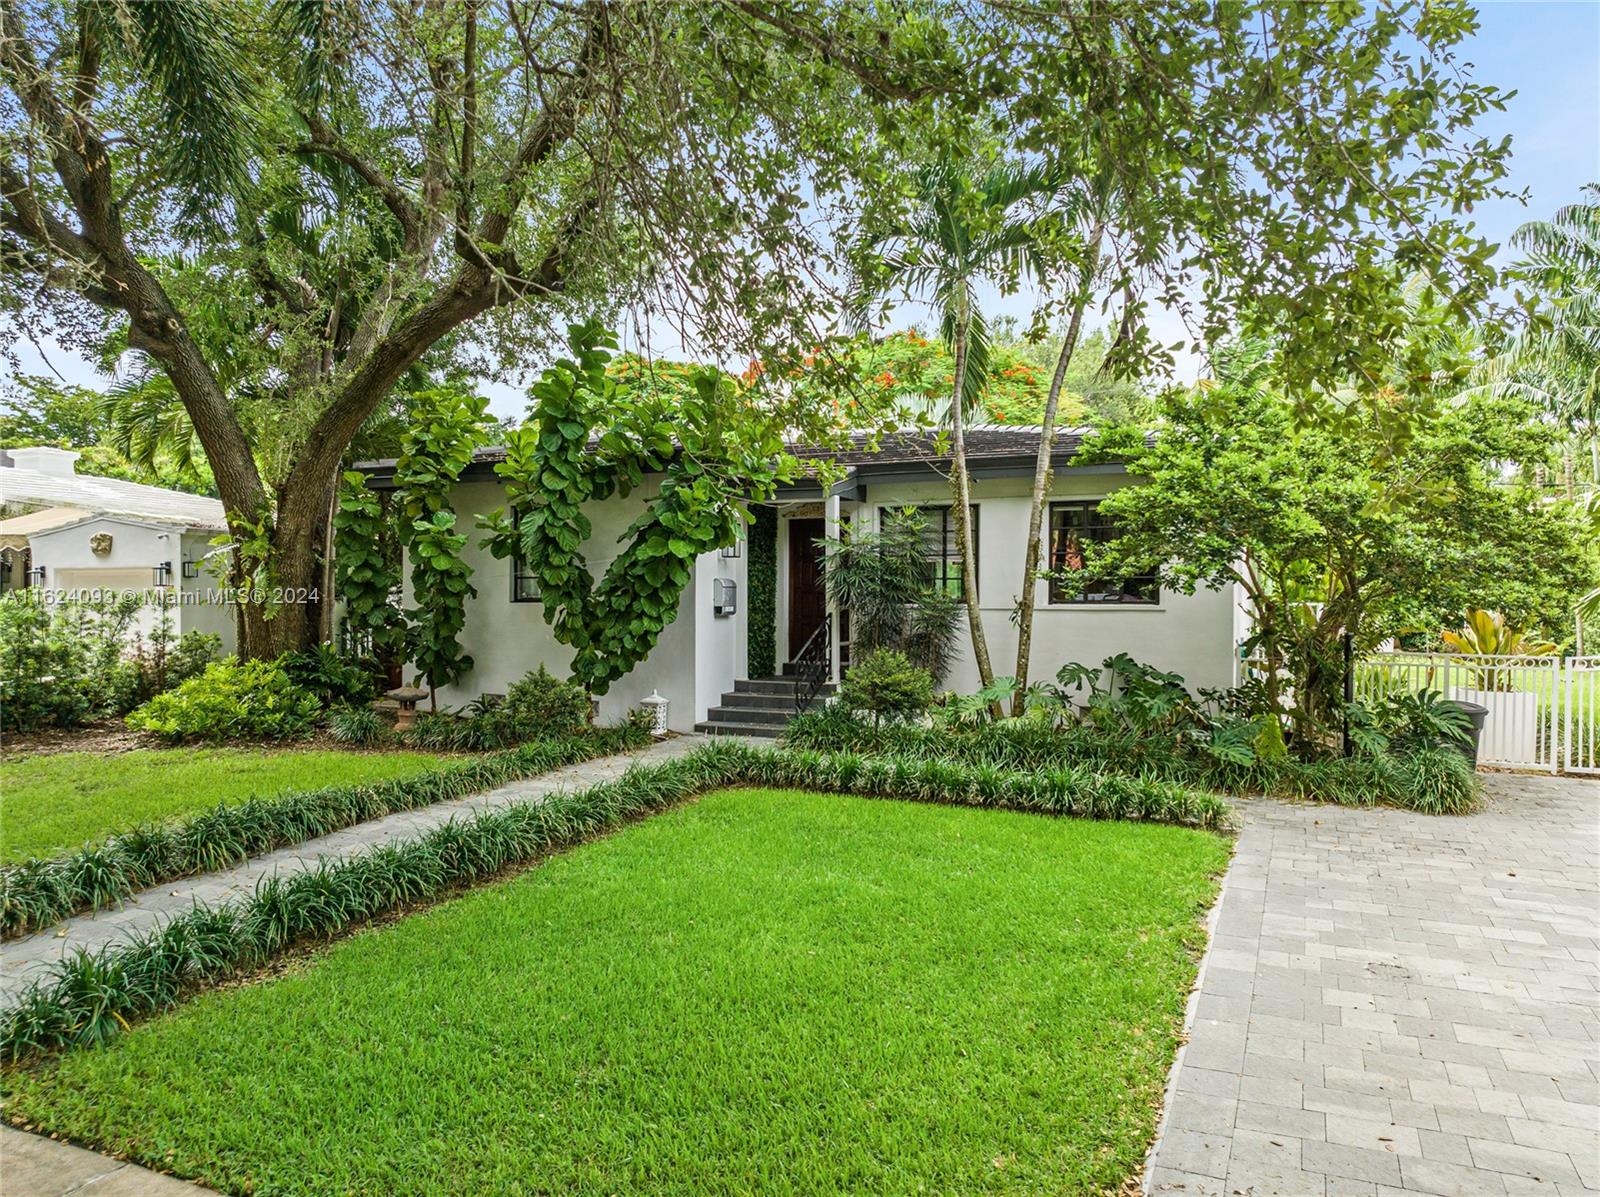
[[1355, 653, 1600, 775]]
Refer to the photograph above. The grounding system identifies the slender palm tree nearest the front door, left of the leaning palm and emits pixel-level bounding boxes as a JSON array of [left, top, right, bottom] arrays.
[[867, 162, 1062, 687]]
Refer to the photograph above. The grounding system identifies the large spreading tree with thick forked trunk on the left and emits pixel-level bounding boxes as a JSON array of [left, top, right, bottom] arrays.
[[0, 0, 987, 655]]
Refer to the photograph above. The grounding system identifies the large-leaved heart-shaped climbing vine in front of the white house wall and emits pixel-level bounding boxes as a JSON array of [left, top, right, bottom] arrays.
[[482, 322, 794, 695]]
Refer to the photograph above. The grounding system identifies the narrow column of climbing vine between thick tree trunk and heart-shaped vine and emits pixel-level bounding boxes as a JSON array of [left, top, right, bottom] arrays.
[[395, 387, 488, 690]]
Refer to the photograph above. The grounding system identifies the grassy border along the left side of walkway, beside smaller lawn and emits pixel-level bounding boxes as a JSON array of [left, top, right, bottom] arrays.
[[0, 723, 650, 939]]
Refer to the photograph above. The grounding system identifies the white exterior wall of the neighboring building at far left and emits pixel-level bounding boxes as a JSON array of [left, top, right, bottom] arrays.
[[29, 515, 235, 655]]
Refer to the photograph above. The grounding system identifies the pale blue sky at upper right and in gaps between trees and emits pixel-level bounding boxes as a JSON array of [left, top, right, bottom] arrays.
[[6, 0, 1600, 414]]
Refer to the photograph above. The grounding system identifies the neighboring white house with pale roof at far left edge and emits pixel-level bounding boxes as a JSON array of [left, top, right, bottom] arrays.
[[0, 448, 235, 651]]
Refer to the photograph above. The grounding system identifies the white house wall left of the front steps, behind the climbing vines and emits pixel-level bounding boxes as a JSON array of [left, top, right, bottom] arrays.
[[405, 478, 746, 731]]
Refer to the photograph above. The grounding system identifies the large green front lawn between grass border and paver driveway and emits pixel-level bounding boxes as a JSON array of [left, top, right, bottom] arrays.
[[6, 791, 1229, 1194]]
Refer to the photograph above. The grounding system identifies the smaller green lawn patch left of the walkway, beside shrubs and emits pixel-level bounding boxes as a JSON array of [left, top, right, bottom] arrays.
[[0, 747, 446, 864]]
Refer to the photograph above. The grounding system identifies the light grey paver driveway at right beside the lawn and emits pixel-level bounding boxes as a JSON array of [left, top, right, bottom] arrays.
[[1146, 775, 1600, 1197]]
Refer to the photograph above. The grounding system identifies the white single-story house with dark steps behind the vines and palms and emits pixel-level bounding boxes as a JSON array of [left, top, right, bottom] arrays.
[[360, 426, 1237, 731]]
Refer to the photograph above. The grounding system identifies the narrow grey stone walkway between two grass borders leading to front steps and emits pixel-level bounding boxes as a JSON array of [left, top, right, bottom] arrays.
[[0, 736, 706, 1007]]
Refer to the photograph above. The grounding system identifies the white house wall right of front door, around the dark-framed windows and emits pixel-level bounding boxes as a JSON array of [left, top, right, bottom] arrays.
[[844, 470, 1235, 693]]
